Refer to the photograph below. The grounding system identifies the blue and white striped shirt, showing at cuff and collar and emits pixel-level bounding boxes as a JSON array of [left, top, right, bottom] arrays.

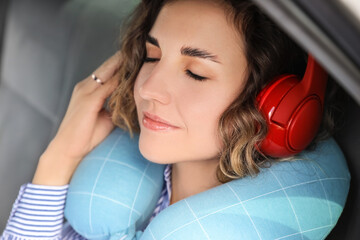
[[0, 164, 171, 240]]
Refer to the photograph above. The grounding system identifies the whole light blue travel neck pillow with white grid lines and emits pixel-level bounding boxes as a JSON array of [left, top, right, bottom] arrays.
[[65, 128, 350, 240]]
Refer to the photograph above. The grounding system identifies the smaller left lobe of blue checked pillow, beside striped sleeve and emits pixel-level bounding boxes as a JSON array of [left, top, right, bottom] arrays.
[[64, 128, 165, 240]]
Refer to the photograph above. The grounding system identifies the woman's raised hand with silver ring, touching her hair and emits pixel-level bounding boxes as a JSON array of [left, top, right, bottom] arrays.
[[32, 52, 121, 185]]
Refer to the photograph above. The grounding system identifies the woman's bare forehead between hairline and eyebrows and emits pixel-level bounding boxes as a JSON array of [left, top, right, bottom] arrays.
[[150, 0, 242, 55]]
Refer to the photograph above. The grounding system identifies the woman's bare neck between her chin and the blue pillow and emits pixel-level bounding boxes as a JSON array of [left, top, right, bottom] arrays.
[[170, 159, 221, 204]]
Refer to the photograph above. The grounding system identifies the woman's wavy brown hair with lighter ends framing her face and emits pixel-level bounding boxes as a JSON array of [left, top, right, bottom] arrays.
[[108, 0, 331, 183]]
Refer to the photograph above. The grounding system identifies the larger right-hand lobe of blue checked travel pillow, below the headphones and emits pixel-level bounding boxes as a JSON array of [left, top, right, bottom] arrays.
[[141, 139, 350, 240]]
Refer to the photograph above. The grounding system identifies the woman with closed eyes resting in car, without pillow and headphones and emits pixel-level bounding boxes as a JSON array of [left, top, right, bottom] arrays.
[[3, 0, 334, 239]]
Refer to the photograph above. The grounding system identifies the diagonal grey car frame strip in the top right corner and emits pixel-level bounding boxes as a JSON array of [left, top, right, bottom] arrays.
[[254, 0, 360, 105]]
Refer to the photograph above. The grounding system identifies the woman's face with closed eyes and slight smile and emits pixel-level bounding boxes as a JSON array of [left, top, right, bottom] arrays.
[[134, 0, 246, 164]]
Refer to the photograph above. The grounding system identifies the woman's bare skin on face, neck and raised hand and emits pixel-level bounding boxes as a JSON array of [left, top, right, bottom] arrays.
[[32, 0, 246, 204]]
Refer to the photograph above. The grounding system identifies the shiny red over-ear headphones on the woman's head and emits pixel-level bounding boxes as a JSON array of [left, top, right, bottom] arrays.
[[257, 55, 327, 157]]
